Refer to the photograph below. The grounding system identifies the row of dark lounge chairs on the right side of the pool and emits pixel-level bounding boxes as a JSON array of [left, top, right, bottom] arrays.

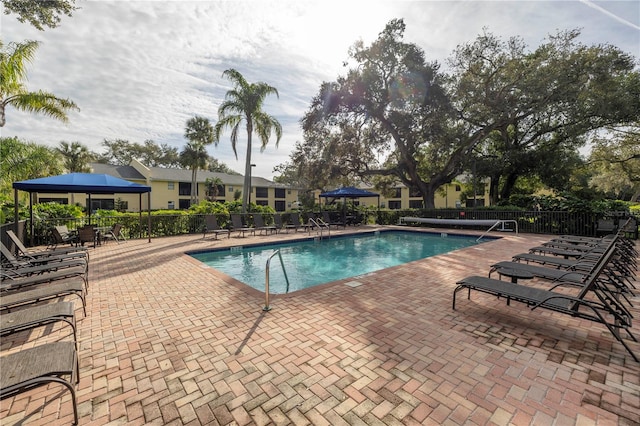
[[453, 220, 640, 362]]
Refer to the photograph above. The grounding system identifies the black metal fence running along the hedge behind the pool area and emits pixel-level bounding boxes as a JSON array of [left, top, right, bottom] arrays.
[[0, 209, 640, 245]]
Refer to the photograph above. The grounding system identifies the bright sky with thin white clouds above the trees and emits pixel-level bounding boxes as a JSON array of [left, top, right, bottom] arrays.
[[0, 0, 640, 179]]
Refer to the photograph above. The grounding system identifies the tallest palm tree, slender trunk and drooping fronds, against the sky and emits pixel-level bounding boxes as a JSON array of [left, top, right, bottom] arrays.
[[215, 69, 282, 213]]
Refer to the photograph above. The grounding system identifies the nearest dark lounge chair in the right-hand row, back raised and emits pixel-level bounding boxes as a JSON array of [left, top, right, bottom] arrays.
[[452, 256, 640, 362]]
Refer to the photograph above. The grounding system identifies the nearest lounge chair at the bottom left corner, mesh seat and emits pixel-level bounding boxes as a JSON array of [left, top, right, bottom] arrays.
[[0, 342, 80, 424]]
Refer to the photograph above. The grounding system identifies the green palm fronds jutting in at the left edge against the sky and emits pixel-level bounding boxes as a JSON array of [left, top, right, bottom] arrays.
[[0, 40, 79, 127]]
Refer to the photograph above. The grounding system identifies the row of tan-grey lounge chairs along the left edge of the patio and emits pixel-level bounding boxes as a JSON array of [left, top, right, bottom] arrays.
[[0, 231, 89, 424]]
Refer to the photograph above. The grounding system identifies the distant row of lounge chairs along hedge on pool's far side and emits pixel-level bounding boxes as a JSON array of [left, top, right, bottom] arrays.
[[202, 212, 345, 239]]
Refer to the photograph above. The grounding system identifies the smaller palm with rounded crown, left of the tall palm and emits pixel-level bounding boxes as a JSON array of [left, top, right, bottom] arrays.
[[180, 116, 214, 204]]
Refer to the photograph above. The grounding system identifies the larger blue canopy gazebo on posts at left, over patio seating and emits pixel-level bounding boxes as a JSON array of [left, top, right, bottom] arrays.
[[12, 173, 151, 242]]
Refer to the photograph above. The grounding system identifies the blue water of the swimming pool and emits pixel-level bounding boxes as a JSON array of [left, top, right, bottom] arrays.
[[190, 231, 488, 294]]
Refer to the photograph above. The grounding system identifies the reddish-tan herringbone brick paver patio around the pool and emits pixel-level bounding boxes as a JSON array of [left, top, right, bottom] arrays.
[[0, 225, 640, 425]]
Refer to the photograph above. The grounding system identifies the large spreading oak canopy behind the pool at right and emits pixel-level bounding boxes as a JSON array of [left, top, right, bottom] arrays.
[[280, 20, 640, 208]]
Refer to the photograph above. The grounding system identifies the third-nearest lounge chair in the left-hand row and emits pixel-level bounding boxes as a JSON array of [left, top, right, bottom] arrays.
[[0, 280, 87, 317]]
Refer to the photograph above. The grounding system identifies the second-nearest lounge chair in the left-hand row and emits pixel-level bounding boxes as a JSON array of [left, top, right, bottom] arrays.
[[0, 302, 78, 349]]
